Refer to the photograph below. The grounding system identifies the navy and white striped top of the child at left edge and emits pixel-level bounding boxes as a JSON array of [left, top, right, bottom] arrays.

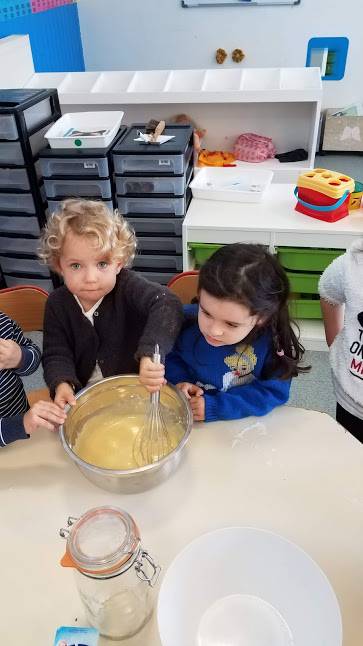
[[0, 312, 41, 448]]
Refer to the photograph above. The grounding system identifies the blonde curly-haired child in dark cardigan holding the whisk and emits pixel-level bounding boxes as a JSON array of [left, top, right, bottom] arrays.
[[39, 199, 183, 408]]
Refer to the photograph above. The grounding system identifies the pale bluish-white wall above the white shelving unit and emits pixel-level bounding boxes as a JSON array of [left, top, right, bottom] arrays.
[[78, 0, 363, 107]]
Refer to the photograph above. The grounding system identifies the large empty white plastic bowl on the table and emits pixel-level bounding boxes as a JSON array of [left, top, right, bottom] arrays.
[[158, 527, 342, 646]]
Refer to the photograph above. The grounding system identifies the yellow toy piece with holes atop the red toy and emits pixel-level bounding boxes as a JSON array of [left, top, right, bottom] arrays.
[[297, 168, 355, 200]]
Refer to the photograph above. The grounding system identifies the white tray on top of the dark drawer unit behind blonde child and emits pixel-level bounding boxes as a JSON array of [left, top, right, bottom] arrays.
[[45, 111, 124, 148]]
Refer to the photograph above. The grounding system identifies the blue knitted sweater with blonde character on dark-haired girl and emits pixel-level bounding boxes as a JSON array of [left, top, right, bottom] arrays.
[[165, 325, 291, 422]]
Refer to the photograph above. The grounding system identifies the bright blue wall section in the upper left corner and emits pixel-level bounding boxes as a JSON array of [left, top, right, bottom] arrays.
[[0, 2, 85, 72]]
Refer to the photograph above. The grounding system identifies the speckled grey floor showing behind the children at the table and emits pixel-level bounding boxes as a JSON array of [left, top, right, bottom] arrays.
[[23, 332, 335, 417]]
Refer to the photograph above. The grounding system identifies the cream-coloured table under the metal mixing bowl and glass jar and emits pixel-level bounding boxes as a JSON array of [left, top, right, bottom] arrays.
[[0, 406, 363, 646]]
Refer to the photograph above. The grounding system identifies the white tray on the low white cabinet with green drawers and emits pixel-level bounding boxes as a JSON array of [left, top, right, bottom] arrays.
[[190, 167, 273, 202]]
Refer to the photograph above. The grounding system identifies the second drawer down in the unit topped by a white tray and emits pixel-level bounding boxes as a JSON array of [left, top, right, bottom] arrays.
[[44, 178, 112, 199]]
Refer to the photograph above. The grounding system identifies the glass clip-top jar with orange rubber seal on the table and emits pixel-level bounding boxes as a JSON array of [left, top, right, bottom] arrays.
[[60, 507, 160, 639]]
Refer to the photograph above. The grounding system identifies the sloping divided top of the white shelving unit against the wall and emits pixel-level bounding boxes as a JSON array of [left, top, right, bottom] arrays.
[[26, 67, 321, 104]]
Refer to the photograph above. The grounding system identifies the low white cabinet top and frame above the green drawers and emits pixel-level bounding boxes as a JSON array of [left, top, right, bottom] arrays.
[[183, 184, 363, 262]]
